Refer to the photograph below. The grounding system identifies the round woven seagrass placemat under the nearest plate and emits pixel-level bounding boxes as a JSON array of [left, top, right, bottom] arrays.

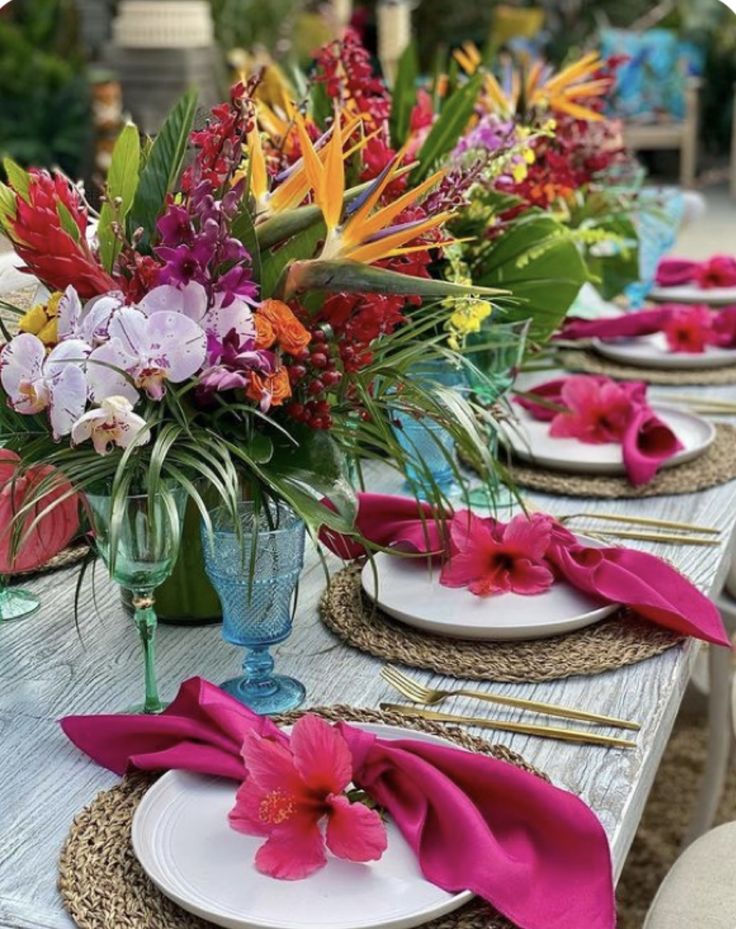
[[59, 706, 548, 929]]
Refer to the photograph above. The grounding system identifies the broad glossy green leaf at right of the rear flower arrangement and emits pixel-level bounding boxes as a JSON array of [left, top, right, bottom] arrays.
[[473, 213, 588, 343]]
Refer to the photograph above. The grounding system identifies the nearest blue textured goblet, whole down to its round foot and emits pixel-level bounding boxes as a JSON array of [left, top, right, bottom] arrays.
[[202, 502, 306, 716]]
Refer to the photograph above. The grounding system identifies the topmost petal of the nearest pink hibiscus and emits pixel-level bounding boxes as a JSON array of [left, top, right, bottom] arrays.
[[290, 713, 353, 796]]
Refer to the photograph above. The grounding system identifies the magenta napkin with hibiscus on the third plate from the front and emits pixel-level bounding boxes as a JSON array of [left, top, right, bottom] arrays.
[[514, 374, 683, 486]]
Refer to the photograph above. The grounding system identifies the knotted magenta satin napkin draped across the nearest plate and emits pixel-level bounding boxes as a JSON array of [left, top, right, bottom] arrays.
[[61, 678, 616, 929]]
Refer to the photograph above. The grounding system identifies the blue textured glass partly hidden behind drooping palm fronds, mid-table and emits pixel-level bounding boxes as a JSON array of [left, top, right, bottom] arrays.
[[391, 359, 466, 500]]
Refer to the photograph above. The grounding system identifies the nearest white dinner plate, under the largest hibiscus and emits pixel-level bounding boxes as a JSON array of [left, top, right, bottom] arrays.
[[132, 723, 473, 929]]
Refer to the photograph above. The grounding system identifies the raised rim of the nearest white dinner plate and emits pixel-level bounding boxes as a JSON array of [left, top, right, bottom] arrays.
[[131, 724, 474, 929]]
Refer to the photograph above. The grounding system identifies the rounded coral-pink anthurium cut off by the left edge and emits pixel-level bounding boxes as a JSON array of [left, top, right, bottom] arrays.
[[0, 448, 79, 574]]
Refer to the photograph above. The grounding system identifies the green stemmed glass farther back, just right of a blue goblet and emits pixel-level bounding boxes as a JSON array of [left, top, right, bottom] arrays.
[[465, 319, 531, 510]]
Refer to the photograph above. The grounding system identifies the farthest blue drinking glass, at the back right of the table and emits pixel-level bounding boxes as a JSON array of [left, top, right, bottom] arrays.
[[624, 187, 685, 309]]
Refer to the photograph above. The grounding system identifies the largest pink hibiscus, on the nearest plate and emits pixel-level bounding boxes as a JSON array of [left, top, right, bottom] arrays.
[[229, 714, 386, 880]]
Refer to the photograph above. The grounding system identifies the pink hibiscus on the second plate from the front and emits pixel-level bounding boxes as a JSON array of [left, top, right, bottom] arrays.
[[440, 510, 554, 597]]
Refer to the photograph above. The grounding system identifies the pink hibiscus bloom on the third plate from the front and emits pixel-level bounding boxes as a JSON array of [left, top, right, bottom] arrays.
[[549, 374, 631, 445]]
